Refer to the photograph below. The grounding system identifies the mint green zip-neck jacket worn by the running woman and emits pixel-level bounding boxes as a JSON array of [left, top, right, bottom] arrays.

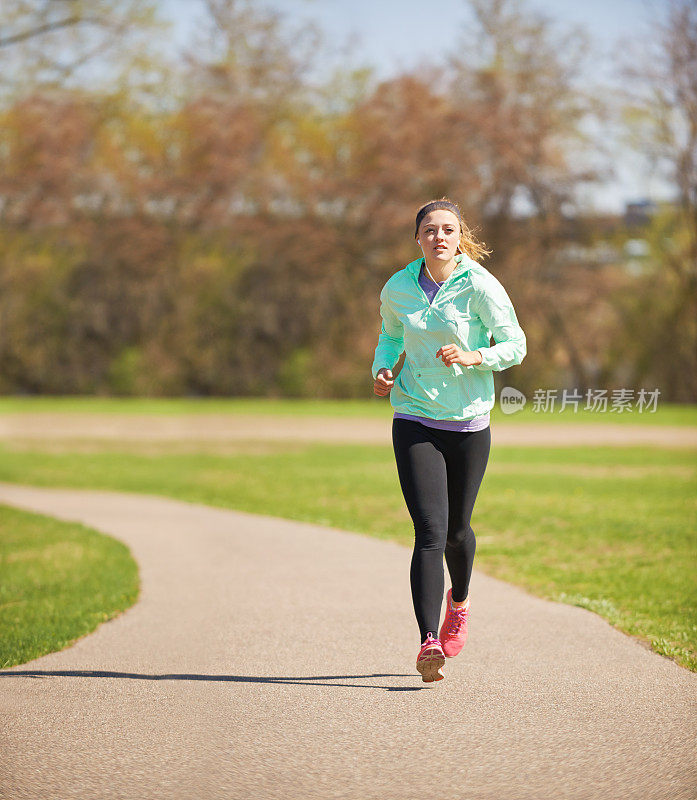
[[372, 254, 527, 420]]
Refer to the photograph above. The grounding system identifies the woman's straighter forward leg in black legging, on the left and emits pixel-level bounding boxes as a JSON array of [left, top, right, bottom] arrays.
[[392, 419, 448, 642]]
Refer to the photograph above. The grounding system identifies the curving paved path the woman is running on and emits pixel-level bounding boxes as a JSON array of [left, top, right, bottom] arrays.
[[0, 484, 697, 800]]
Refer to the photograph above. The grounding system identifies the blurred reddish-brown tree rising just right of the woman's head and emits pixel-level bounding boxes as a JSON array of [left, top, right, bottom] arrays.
[[448, 0, 602, 389]]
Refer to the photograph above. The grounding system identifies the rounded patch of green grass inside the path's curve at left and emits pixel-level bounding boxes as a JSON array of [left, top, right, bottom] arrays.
[[0, 505, 139, 668]]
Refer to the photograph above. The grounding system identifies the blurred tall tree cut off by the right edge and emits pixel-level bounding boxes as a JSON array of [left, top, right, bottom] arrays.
[[617, 0, 697, 402]]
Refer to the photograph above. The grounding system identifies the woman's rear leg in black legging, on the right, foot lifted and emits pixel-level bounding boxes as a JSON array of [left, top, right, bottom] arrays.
[[445, 427, 491, 603]]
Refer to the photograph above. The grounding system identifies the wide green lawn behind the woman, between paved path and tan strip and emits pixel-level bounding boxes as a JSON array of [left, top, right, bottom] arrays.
[[0, 443, 697, 670]]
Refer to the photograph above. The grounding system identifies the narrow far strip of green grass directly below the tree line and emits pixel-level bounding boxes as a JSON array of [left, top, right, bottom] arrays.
[[0, 394, 697, 427]]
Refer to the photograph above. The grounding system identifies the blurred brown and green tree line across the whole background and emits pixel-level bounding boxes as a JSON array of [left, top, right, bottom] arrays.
[[0, 0, 697, 401]]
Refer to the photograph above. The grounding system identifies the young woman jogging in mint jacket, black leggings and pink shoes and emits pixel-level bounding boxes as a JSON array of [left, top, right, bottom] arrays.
[[372, 198, 526, 683]]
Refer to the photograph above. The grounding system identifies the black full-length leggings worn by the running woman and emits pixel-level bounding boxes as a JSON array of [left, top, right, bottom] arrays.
[[392, 419, 491, 642]]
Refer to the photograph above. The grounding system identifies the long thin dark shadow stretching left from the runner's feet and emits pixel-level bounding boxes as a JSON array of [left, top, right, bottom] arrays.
[[0, 669, 426, 692]]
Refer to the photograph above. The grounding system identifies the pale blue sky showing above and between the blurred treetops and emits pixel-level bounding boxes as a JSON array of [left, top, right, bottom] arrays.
[[160, 0, 669, 212]]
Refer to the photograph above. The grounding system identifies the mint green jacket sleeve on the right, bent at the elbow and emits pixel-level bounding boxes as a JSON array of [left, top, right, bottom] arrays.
[[474, 275, 527, 371]]
